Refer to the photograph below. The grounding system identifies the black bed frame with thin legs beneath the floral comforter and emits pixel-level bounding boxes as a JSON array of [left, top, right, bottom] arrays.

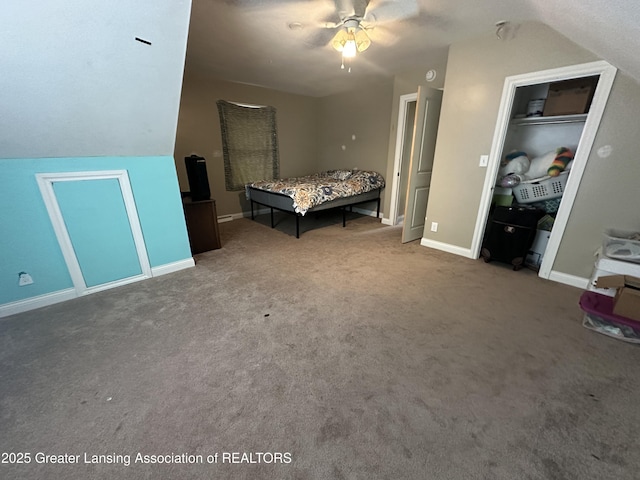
[[248, 187, 382, 238]]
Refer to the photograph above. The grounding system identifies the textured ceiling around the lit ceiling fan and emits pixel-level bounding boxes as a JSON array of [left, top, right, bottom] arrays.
[[186, 0, 640, 96]]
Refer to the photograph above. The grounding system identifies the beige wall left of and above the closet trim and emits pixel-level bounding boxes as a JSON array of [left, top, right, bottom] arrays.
[[424, 23, 598, 250]]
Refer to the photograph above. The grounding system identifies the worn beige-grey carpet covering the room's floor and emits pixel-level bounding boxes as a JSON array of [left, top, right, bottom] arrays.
[[0, 214, 640, 480]]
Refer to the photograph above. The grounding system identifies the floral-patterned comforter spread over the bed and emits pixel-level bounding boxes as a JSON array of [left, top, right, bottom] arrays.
[[245, 170, 384, 215]]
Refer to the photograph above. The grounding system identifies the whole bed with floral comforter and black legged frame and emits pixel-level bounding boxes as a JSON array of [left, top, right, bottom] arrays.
[[245, 170, 385, 238]]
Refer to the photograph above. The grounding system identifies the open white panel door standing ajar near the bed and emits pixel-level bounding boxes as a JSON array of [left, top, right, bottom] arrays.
[[402, 85, 442, 243]]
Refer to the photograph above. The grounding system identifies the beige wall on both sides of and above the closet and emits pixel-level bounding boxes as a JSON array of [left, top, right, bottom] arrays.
[[424, 23, 640, 278]]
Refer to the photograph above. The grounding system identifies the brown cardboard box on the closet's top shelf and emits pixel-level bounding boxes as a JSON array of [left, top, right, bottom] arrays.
[[542, 77, 598, 117]]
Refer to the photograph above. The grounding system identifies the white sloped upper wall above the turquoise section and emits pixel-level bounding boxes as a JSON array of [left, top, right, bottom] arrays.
[[0, 0, 191, 158]]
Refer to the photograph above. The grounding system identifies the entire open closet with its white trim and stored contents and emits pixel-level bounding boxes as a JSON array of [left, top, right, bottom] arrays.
[[471, 61, 616, 287]]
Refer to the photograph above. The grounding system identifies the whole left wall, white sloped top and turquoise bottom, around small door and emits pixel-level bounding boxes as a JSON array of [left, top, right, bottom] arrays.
[[0, 0, 193, 316]]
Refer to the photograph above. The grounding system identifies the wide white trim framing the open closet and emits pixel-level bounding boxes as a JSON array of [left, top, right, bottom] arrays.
[[471, 61, 617, 284]]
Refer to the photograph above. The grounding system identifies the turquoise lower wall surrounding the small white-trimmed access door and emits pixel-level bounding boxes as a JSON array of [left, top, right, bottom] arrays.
[[0, 156, 191, 304]]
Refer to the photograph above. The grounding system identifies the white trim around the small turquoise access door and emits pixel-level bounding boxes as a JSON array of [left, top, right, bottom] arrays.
[[36, 170, 152, 296]]
